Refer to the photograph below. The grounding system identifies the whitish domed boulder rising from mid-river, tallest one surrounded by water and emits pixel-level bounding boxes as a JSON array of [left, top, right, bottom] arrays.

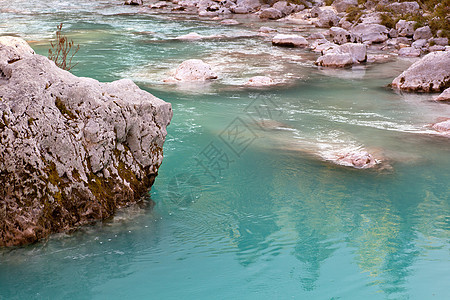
[[173, 59, 217, 82]]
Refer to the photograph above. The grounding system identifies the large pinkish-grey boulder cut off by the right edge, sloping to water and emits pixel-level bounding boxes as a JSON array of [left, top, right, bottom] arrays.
[[392, 51, 450, 92]]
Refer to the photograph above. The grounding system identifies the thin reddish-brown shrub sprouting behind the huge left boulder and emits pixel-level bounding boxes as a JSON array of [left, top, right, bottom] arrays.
[[48, 23, 80, 71]]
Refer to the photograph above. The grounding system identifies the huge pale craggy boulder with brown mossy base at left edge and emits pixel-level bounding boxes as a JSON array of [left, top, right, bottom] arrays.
[[0, 37, 172, 246]]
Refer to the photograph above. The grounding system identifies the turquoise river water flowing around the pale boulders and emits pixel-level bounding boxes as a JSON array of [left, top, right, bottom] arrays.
[[0, 1, 450, 299]]
